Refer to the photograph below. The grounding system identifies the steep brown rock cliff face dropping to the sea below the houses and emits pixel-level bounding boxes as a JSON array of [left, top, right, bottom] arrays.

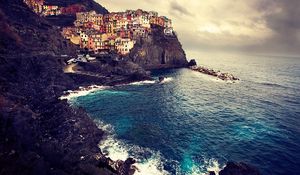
[[129, 26, 188, 69]]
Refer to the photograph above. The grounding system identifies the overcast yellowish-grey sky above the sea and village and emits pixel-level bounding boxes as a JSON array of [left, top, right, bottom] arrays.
[[96, 0, 300, 56]]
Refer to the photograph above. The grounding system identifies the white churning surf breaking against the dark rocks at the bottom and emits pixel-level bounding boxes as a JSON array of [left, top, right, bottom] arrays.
[[95, 120, 224, 175]]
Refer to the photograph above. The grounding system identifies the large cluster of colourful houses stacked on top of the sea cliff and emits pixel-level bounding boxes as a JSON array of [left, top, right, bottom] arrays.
[[62, 9, 173, 55]]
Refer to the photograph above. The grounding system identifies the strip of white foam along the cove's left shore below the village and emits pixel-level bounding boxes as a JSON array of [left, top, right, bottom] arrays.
[[59, 85, 108, 100]]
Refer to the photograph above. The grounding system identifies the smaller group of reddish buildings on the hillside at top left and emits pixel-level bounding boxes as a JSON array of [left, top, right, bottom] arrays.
[[23, 0, 84, 16]]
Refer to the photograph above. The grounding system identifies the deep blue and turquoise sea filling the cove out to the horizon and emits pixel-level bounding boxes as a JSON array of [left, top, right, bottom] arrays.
[[69, 55, 300, 175]]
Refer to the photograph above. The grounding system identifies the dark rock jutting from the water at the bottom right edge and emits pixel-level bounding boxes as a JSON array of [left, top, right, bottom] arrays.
[[219, 162, 260, 175]]
